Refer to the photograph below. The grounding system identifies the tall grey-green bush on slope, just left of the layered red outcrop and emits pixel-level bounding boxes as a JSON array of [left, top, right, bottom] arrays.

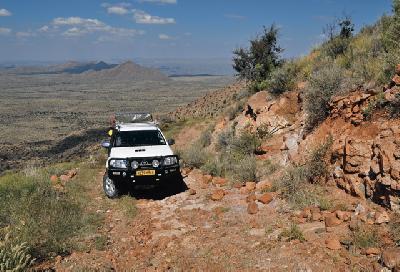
[[304, 64, 344, 131]]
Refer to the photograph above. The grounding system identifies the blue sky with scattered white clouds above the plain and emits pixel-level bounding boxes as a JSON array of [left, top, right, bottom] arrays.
[[0, 0, 391, 62]]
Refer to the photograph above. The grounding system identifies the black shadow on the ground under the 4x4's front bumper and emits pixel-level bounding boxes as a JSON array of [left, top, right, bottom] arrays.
[[129, 175, 189, 200]]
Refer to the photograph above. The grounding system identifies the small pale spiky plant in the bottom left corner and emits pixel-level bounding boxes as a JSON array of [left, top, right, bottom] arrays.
[[0, 233, 34, 272]]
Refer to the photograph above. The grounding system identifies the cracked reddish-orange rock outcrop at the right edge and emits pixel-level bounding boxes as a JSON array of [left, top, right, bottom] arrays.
[[330, 67, 400, 211]]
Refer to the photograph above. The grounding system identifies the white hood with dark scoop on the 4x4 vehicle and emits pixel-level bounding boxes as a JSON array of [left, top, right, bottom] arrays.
[[109, 145, 174, 159]]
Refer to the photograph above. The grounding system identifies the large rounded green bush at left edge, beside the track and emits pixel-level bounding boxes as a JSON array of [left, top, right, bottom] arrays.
[[0, 174, 86, 258]]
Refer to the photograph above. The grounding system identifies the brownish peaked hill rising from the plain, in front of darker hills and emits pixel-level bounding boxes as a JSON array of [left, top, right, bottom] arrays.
[[80, 61, 169, 81]]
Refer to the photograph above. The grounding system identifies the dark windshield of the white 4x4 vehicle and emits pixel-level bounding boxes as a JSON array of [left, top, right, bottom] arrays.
[[114, 130, 166, 147]]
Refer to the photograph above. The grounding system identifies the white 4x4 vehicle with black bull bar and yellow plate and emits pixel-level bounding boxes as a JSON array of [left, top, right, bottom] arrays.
[[102, 114, 181, 198]]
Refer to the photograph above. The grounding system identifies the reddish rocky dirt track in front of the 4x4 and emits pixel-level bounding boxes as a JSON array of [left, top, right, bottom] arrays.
[[50, 170, 394, 271]]
